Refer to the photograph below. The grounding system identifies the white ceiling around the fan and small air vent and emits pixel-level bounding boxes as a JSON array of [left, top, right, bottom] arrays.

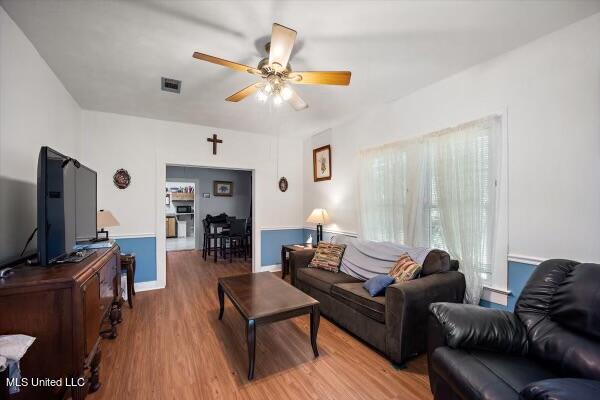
[[0, 0, 600, 134]]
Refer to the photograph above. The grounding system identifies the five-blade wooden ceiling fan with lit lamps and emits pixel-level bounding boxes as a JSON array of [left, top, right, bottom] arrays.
[[193, 23, 351, 111]]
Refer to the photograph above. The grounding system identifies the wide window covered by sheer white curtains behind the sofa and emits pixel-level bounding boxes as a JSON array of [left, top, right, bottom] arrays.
[[360, 116, 501, 303]]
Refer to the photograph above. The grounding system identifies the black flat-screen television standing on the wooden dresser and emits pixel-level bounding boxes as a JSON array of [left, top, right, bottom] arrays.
[[37, 146, 97, 265]]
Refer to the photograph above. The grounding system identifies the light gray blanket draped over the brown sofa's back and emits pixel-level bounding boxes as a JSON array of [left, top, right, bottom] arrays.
[[333, 235, 432, 281]]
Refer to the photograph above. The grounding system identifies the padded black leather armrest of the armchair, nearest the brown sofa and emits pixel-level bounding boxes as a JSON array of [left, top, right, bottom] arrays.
[[430, 303, 527, 354]]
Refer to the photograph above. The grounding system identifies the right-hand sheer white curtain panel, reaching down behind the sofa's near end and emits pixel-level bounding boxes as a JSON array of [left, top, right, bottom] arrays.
[[427, 117, 500, 304]]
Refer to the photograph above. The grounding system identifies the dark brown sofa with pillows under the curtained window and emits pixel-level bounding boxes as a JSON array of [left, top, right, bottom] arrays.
[[289, 249, 465, 365]]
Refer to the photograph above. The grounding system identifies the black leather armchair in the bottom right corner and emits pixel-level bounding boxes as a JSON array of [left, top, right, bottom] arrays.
[[428, 260, 600, 400]]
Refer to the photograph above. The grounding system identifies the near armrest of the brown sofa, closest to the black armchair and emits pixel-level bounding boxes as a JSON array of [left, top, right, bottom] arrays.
[[385, 271, 465, 364]]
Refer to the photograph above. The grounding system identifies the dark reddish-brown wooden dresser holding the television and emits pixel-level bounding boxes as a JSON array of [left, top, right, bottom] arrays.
[[0, 245, 122, 400]]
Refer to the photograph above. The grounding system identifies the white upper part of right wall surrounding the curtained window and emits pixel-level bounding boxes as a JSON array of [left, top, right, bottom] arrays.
[[303, 14, 600, 282]]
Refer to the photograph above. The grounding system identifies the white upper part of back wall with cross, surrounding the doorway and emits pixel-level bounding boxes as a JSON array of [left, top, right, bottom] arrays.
[[82, 111, 303, 281]]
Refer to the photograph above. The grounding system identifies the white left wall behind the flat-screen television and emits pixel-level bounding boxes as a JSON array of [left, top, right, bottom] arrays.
[[0, 7, 81, 262]]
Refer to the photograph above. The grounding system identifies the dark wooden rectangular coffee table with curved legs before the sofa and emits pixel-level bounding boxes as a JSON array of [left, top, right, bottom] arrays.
[[217, 272, 320, 380]]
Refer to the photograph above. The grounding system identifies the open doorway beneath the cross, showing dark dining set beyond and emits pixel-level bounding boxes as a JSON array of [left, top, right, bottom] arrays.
[[165, 164, 253, 270]]
